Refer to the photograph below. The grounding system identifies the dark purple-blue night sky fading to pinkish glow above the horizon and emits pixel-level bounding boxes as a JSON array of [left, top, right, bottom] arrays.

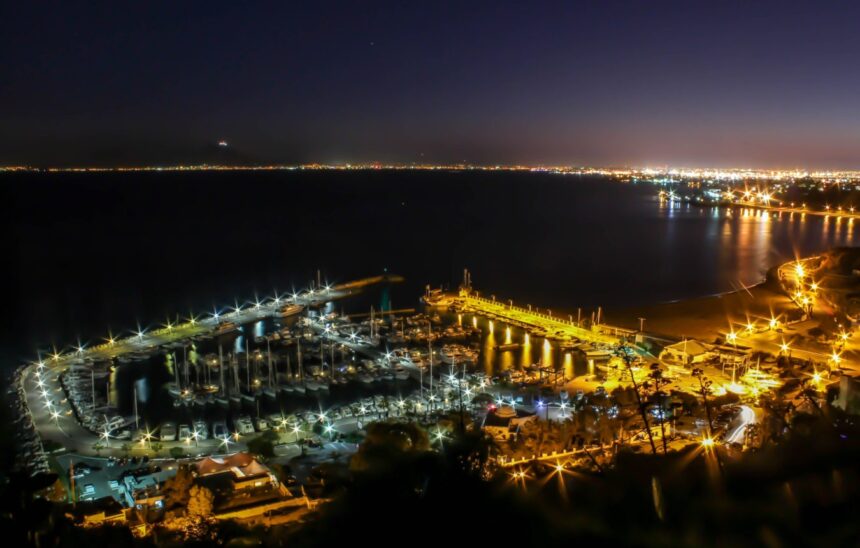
[[0, 0, 860, 168]]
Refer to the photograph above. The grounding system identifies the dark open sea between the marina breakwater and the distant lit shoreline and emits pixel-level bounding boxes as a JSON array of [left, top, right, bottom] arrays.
[[5, 171, 857, 366]]
